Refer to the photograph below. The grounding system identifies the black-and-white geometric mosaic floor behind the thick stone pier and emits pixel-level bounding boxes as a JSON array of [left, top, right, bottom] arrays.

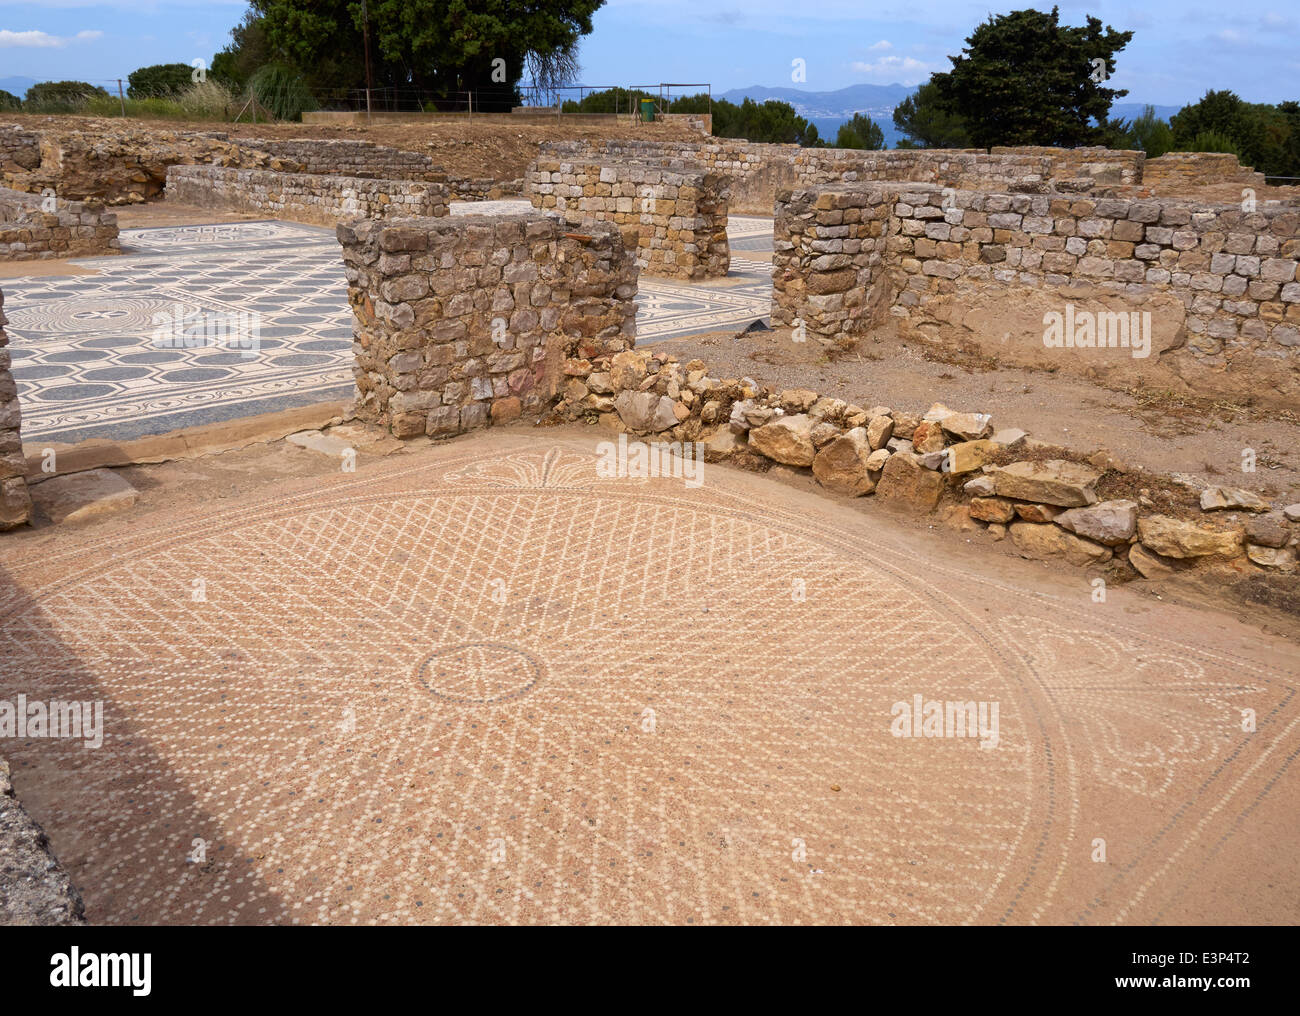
[[3, 213, 771, 442]]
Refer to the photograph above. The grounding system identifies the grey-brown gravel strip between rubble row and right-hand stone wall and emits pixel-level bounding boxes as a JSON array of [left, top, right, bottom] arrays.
[[657, 330, 1300, 504]]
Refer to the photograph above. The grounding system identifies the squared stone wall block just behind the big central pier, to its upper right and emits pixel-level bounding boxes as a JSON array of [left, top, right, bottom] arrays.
[[525, 159, 731, 279]]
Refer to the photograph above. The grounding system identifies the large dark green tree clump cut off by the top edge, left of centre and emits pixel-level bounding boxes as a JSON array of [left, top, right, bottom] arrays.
[[221, 0, 605, 110]]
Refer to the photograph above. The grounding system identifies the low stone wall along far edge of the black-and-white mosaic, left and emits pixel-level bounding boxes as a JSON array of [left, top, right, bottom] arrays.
[[166, 166, 450, 226]]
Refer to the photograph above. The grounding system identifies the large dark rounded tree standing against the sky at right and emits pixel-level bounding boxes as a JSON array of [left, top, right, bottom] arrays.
[[931, 8, 1132, 148]]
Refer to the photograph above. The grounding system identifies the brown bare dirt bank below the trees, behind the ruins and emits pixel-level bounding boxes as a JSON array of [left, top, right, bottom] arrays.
[[5, 117, 701, 181]]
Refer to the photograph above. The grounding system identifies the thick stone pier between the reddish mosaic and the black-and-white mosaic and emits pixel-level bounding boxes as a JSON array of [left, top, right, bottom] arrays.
[[338, 216, 637, 438]]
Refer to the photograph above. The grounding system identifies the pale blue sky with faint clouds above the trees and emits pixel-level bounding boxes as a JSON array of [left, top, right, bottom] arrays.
[[0, 0, 1300, 104]]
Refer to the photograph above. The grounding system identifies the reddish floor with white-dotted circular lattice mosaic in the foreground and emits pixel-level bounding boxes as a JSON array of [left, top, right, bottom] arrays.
[[0, 435, 1300, 924]]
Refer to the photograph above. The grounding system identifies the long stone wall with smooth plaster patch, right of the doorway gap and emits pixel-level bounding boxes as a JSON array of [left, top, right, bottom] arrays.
[[774, 184, 1300, 407]]
